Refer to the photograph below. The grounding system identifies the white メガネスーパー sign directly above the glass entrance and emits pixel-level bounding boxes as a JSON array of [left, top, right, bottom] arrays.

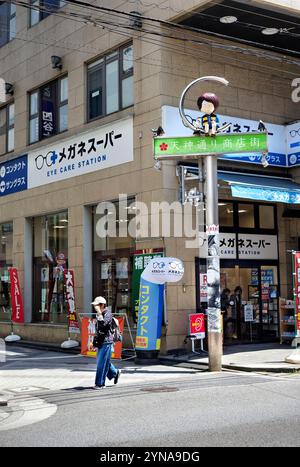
[[200, 233, 278, 259]]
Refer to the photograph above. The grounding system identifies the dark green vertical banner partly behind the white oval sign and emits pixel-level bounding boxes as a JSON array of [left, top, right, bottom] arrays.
[[131, 251, 164, 323]]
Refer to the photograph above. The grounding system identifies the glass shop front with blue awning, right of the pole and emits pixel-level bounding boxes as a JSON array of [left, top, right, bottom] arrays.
[[196, 172, 300, 343]]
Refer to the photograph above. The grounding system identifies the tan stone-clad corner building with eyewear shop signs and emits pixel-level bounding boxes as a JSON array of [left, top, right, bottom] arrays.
[[0, 1, 300, 352]]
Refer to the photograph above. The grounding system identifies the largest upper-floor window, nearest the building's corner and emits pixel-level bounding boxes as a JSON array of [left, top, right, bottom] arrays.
[[87, 44, 133, 120]]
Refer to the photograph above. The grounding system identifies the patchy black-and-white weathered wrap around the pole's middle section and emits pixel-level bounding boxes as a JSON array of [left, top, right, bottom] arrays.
[[206, 225, 222, 333]]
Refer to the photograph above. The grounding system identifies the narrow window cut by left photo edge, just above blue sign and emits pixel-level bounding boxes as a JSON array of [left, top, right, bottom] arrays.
[[0, 103, 15, 155]]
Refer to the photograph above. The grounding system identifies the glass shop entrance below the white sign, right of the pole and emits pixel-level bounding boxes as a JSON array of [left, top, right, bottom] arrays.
[[221, 260, 279, 343]]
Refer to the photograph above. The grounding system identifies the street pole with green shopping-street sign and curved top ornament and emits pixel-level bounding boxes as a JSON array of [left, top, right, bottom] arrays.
[[152, 76, 268, 371]]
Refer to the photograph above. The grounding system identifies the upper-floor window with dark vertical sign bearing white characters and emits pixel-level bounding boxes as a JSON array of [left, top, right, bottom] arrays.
[[29, 76, 68, 144]]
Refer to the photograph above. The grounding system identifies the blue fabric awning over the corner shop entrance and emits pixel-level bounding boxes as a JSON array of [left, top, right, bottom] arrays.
[[218, 171, 300, 204]]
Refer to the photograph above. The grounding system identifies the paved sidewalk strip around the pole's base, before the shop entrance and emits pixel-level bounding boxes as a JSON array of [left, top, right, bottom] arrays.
[[160, 343, 300, 373]]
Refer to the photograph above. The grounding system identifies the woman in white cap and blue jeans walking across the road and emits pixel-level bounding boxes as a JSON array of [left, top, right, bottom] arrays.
[[91, 297, 121, 389]]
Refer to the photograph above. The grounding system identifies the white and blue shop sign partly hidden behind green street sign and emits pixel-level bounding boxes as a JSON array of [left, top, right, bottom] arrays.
[[162, 106, 286, 167]]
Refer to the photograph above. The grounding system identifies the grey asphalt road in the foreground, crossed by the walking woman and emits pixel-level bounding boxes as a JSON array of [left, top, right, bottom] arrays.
[[0, 349, 300, 447]]
